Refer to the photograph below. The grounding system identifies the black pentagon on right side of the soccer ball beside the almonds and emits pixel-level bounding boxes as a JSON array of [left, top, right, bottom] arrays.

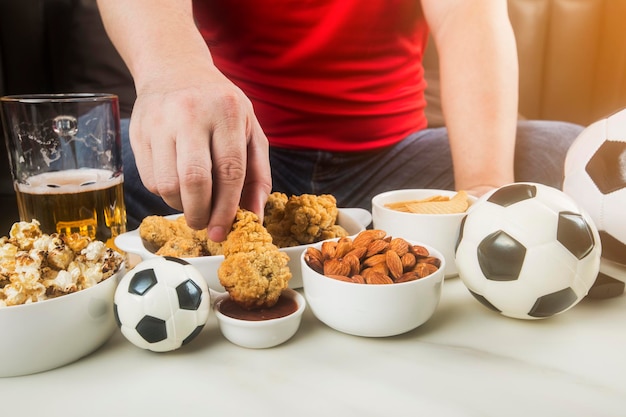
[[556, 211, 595, 259]]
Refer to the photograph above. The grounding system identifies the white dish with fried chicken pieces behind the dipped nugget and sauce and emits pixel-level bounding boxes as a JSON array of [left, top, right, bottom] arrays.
[[115, 192, 371, 292]]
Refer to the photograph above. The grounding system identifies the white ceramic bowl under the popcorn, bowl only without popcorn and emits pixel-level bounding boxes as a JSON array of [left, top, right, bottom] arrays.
[[0, 268, 124, 377]]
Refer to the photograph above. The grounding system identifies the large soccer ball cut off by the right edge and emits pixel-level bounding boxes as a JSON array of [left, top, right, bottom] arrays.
[[563, 109, 626, 292]]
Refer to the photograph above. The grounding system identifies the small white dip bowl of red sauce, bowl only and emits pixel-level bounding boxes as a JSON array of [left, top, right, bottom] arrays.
[[213, 288, 306, 349]]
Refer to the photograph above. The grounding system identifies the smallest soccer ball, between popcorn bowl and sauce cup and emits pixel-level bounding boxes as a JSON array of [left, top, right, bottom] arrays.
[[114, 257, 210, 352]]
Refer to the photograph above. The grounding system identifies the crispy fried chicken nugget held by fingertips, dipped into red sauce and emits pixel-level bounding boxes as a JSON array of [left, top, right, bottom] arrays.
[[217, 209, 291, 309]]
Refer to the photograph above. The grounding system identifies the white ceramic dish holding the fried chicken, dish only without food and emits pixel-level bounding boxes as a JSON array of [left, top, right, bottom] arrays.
[[115, 208, 372, 292]]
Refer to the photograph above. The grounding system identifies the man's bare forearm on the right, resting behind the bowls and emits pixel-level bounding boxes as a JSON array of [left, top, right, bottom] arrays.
[[422, 0, 518, 195]]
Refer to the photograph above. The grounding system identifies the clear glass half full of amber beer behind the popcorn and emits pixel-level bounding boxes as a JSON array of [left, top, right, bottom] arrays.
[[0, 93, 126, 248]]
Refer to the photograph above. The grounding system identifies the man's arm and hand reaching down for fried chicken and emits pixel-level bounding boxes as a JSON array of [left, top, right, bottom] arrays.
[[98, 0, 271, 241]]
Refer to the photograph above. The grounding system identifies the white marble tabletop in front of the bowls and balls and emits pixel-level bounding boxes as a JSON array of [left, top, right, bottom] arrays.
[[0, 278, 626, 417]]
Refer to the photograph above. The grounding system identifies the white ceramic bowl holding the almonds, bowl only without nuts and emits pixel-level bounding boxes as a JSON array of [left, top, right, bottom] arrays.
[[300, 241, 445, 337]]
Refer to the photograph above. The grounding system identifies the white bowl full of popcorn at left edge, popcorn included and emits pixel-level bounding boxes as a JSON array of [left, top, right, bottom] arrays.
[[0, 222, 124, 377]]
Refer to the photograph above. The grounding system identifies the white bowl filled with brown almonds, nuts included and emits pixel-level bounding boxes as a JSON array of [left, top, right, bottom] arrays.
[[300, 229, 445, 337]]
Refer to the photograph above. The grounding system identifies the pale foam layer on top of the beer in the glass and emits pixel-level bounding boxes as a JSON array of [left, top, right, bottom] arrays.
[[17, 168, 124, 194]]
